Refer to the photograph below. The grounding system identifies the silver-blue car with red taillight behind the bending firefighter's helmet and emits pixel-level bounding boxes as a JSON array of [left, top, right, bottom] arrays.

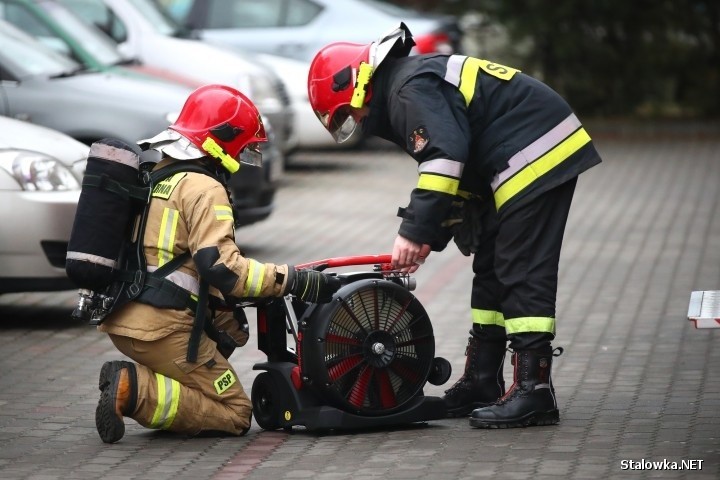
[[155, 0, 461, 61]]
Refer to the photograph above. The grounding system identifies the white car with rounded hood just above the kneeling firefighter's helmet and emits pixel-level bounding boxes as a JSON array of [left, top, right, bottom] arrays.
[[58, 0, 297, 153]]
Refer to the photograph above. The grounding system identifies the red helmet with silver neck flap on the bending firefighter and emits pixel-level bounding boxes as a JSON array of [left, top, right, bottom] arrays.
[[308, 23, 415, 143]]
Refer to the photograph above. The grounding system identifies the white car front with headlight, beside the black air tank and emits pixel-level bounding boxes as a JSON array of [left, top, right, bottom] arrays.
[[0, 116, 89, 293]]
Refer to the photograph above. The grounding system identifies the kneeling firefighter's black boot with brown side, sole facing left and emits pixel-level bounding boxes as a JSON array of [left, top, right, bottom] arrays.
[[95, 362, 137, 443]]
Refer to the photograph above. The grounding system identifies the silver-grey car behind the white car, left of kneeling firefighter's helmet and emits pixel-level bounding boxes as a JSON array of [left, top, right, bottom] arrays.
[[0, 22, 192, 144]]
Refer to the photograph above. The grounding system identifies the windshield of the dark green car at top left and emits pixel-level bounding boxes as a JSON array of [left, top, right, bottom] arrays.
[[42, 3, 125, 65]]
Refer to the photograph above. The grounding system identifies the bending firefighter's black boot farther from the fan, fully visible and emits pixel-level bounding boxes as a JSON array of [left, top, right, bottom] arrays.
[[470, 346, 562, 428]]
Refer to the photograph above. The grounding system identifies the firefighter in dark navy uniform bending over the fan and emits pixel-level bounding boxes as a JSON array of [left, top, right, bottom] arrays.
[[308, 24, 600, 428]]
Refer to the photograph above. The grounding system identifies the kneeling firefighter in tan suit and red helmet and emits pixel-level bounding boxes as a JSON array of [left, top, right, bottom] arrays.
[[89, 85, 340, 443]]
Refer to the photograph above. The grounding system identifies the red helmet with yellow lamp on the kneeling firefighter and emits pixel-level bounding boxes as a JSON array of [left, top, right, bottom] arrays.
[[169, 85, 267, 173]]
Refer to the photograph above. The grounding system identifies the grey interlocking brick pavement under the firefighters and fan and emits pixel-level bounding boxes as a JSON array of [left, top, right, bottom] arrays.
[[0, 129, 720, 480]]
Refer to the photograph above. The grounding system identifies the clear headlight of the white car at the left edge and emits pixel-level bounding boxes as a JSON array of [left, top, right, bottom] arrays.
[[0, 150, 80, 192]]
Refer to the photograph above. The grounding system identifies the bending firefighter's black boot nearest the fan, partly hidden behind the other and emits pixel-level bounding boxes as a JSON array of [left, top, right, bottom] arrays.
[[443, 336, 505, 417]]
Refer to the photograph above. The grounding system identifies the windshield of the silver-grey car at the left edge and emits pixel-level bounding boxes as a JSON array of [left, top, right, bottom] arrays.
[[0, 22, 81, 78]]
